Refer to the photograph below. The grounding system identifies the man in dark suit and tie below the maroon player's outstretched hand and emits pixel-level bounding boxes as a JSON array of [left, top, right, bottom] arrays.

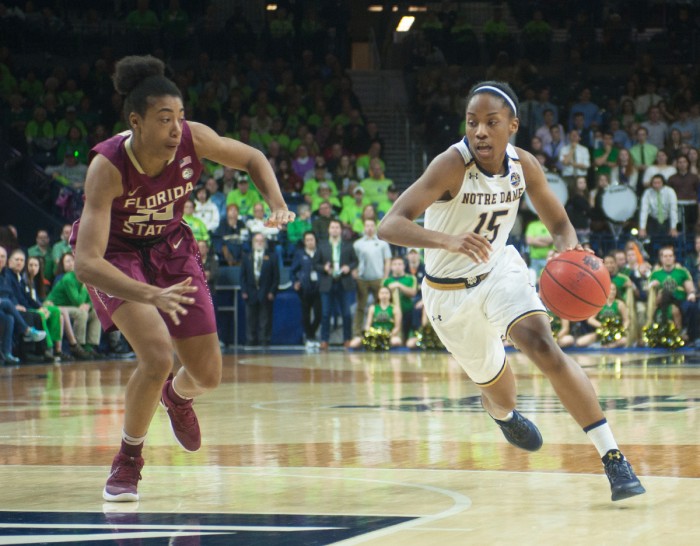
[[241, 233, 280, 347]]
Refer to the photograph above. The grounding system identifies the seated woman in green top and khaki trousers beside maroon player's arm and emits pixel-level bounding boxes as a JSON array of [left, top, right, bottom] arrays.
[[44, 252, 102, 360]]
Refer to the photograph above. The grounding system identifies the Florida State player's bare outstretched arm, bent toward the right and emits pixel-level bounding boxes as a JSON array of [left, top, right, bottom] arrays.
[[189, 121, 295, 226]]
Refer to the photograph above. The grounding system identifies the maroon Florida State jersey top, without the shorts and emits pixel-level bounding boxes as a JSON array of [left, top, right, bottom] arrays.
[[90, 122, 203, 239]]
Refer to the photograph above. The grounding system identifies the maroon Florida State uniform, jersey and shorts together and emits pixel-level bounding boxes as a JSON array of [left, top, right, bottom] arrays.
[[70, 123, 216, 338]]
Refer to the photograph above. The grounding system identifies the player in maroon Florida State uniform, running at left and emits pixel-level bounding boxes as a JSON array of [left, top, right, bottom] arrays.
[[71, 56, 294, 501]]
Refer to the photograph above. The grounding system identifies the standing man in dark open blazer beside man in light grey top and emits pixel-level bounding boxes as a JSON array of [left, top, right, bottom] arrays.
[[314, 219, 357, 350]]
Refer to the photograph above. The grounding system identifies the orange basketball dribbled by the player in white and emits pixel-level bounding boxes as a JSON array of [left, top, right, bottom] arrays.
[[540, 250, 610, 321]]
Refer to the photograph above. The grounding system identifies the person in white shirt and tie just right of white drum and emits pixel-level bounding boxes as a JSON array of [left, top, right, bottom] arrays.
[[639, 174, 678, 239]]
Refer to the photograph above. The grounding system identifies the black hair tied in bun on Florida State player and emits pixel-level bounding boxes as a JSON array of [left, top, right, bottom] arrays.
[[112, 55, 182, 118]]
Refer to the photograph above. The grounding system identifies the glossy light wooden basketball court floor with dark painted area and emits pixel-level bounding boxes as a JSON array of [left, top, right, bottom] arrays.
[[0, 349, 700, 546]]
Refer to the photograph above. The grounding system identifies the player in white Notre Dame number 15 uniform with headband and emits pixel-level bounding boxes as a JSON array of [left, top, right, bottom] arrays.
[[379, 78, 645, 500]]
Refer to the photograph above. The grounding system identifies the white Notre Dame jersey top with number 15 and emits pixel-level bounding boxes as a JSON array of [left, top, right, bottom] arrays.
[[423, 137, 525, 279]]
